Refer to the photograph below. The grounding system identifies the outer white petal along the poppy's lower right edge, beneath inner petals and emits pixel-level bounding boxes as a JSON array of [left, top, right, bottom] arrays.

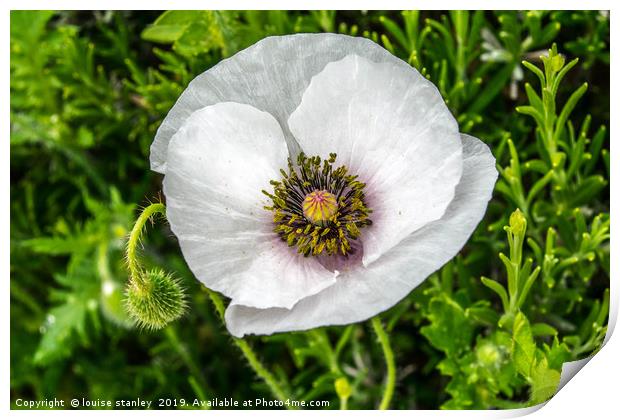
[[226, 135, 497, 336]]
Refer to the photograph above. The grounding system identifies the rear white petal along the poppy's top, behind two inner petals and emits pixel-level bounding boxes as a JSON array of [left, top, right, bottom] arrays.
[[151, 34, 407, 173]]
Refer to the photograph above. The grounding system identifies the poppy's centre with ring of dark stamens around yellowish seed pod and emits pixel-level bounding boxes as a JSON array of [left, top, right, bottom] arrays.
[[263, 153, 372, 257]]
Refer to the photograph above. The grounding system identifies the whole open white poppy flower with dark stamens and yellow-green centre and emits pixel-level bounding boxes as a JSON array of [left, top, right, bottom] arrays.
[[151, 34, 497, 336]]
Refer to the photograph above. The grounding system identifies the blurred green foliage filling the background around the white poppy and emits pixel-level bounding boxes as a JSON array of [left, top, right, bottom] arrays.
[[10, 11, 610, 409]]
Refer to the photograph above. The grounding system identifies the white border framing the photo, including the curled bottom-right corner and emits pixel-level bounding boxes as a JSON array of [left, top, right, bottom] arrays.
[[0, 0, 620, 420]]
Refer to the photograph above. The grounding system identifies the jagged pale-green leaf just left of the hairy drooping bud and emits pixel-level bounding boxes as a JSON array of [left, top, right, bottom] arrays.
[[21, 190, 133, 364]]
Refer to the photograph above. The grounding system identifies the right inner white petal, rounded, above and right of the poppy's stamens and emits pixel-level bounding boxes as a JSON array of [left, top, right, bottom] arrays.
[[289, 55, 462, 265]]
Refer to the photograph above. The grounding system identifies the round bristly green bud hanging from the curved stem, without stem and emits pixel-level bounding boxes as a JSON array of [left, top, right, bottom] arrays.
[[125, 269, 187, 330]]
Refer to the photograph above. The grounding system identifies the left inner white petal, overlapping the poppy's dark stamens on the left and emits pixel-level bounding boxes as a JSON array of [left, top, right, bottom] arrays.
[[164, 102, 334, 308]]
